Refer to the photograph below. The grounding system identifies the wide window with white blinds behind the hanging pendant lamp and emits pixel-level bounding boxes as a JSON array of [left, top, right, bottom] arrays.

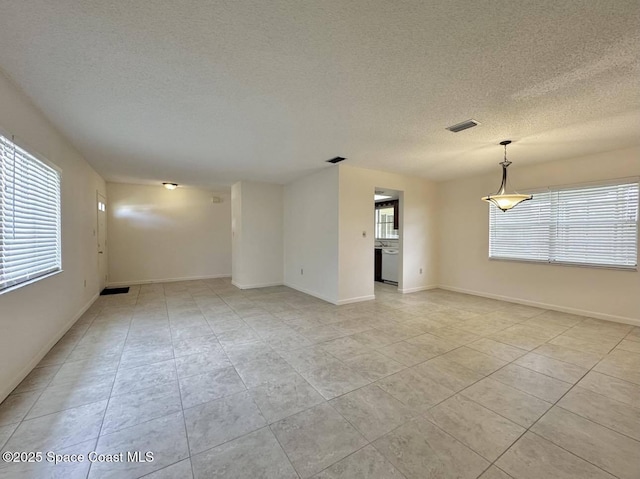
[[489, 181, 638, 269]]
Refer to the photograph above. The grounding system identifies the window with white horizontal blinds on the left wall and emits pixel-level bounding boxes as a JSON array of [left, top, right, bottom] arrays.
[[0, 135, 62, 291]]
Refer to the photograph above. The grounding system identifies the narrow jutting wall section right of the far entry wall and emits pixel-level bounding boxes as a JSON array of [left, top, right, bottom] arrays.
[[231, 181, 283, 289]]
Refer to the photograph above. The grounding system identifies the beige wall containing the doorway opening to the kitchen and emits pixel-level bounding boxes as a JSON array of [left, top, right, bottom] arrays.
[[339, 165, 438, 304]]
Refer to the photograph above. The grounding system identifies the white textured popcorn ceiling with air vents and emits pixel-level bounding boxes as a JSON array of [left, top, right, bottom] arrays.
[[0, 0, 640, 187]]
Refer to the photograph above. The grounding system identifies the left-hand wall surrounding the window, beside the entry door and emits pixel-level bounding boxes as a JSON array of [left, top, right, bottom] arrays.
[[0, 73, 105, 401]]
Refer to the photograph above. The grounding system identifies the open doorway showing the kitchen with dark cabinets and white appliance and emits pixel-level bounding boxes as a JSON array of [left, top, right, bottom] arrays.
[[373, 188, 402, 291]]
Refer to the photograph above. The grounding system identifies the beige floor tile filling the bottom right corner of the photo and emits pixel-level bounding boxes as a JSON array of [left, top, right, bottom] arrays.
[[531, 407, 640, 479]]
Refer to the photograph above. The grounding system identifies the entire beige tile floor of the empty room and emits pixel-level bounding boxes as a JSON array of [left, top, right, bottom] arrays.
[[0, 279, 640, 479]]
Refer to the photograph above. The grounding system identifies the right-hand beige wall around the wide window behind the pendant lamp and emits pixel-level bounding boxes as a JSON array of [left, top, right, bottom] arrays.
[[439, 148, 640, 324]]
